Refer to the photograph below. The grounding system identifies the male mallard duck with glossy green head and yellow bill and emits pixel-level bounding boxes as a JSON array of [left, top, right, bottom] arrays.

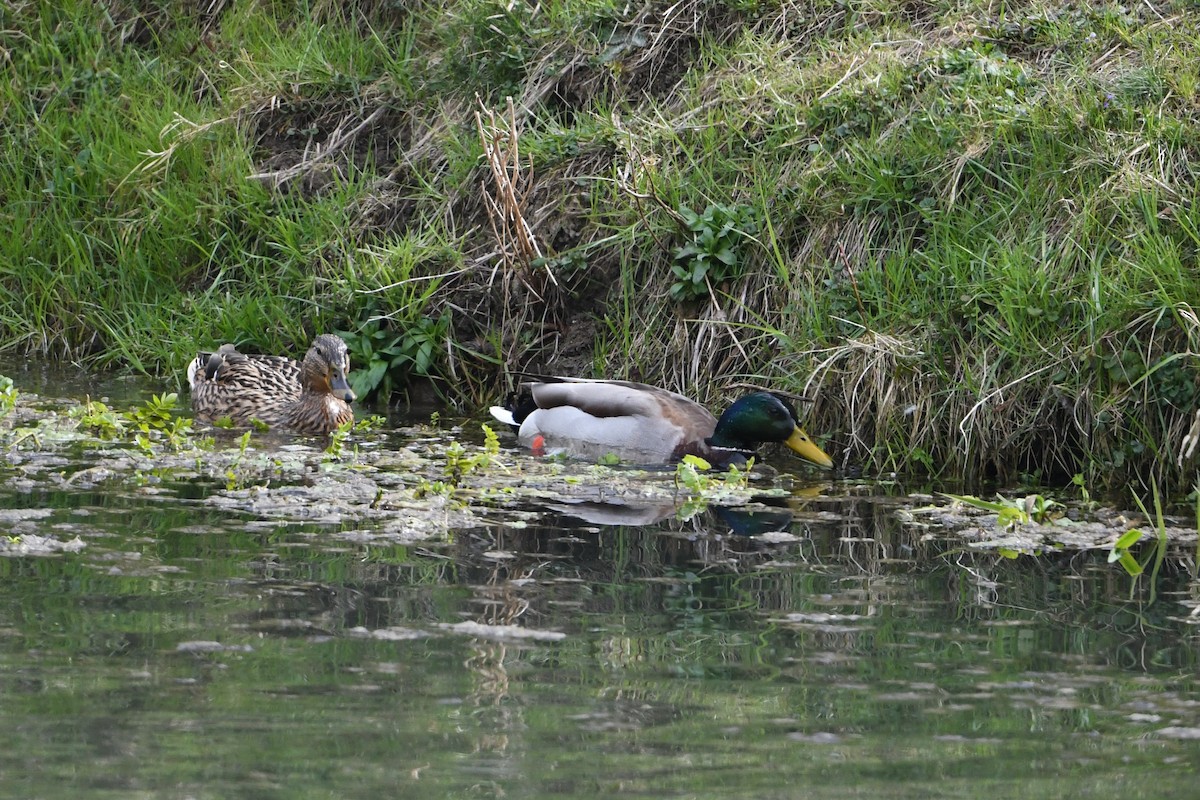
[[491, 378, 833, 467]]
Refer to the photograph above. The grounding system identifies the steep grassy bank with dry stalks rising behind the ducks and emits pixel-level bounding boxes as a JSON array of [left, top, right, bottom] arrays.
[[7, 0, 1200, 492]]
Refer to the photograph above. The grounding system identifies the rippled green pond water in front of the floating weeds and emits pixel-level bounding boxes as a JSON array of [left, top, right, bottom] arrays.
[[0, 367, 1200, 800]]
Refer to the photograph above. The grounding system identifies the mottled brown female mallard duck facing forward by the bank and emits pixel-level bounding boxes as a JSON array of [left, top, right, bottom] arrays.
[[187, 333, 354, 433]]
